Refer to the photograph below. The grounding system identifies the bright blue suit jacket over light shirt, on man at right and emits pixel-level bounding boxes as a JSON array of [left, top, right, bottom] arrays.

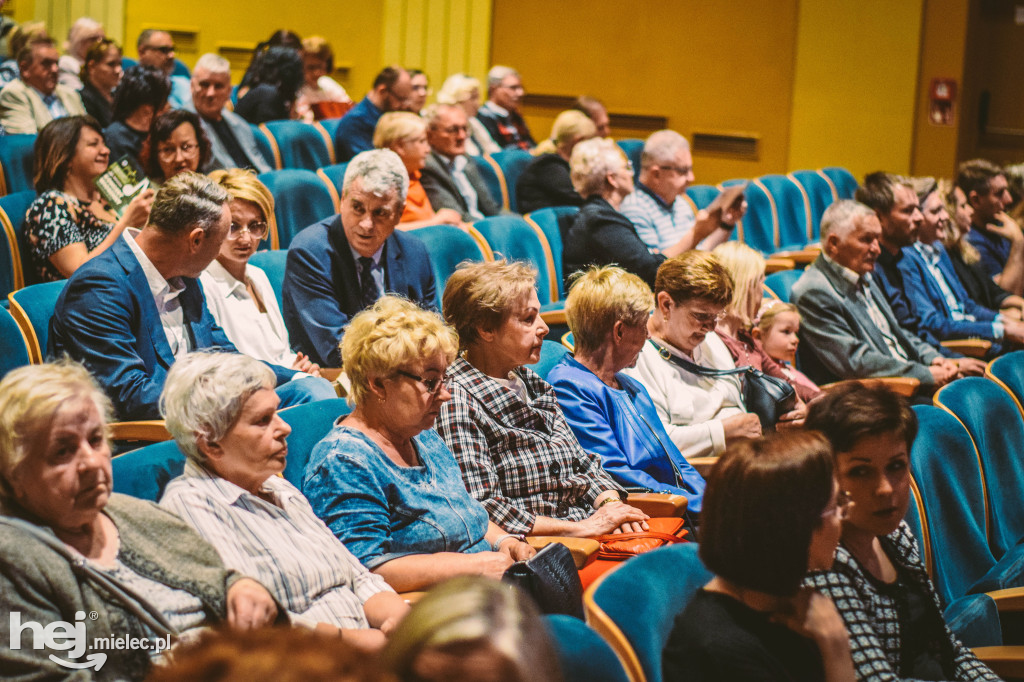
[[899, 246, 998, 341]]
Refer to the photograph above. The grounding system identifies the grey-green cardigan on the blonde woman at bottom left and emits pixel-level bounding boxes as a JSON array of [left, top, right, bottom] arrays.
[[0, 494, 242, 680]]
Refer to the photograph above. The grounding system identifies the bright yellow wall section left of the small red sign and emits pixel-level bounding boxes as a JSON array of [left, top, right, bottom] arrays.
[[788, 0, 924, 178]]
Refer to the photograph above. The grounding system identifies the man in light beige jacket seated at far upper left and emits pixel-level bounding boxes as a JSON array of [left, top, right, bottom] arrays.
[[0, 37, 85, 135]]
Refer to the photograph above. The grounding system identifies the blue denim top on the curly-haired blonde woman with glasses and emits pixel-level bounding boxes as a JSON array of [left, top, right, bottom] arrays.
[[302, 426, 490, 569]]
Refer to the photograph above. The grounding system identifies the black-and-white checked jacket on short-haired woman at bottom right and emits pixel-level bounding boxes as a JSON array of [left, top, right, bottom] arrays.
[[806, 522, 999, 682]]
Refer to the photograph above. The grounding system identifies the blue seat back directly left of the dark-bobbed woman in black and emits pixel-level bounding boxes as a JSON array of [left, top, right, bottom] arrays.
[[593, 543, 712, 682]]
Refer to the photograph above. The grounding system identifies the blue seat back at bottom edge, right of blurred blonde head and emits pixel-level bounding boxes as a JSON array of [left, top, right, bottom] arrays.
[[543, 614, 629, 682]]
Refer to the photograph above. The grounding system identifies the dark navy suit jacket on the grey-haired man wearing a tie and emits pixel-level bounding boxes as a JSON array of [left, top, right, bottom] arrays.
[[282, 216, 435, 368]]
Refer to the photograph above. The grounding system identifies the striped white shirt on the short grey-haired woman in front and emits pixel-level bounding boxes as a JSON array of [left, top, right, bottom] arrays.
[[160, 461, 391, 628]]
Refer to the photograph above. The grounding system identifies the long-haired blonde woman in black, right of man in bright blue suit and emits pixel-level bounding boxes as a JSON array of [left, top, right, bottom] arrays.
[[939, 180, 1024, 319]]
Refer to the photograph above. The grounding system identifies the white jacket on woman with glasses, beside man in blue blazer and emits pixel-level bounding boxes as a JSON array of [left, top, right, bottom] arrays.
[[200, 260, 295, 368]]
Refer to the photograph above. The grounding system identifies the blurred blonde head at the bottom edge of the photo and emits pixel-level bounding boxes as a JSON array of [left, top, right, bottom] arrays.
[[384, 577, 563, 682]]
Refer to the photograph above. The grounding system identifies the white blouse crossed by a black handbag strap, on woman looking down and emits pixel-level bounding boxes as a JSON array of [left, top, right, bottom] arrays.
[[623, 332, 745, 459]]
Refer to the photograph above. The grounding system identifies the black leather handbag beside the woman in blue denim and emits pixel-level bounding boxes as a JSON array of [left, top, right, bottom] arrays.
[[502, 543, 583, 621]]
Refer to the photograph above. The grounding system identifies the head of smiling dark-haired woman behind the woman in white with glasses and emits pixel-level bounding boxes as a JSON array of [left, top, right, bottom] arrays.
[[145, 109, 211, 187]]
